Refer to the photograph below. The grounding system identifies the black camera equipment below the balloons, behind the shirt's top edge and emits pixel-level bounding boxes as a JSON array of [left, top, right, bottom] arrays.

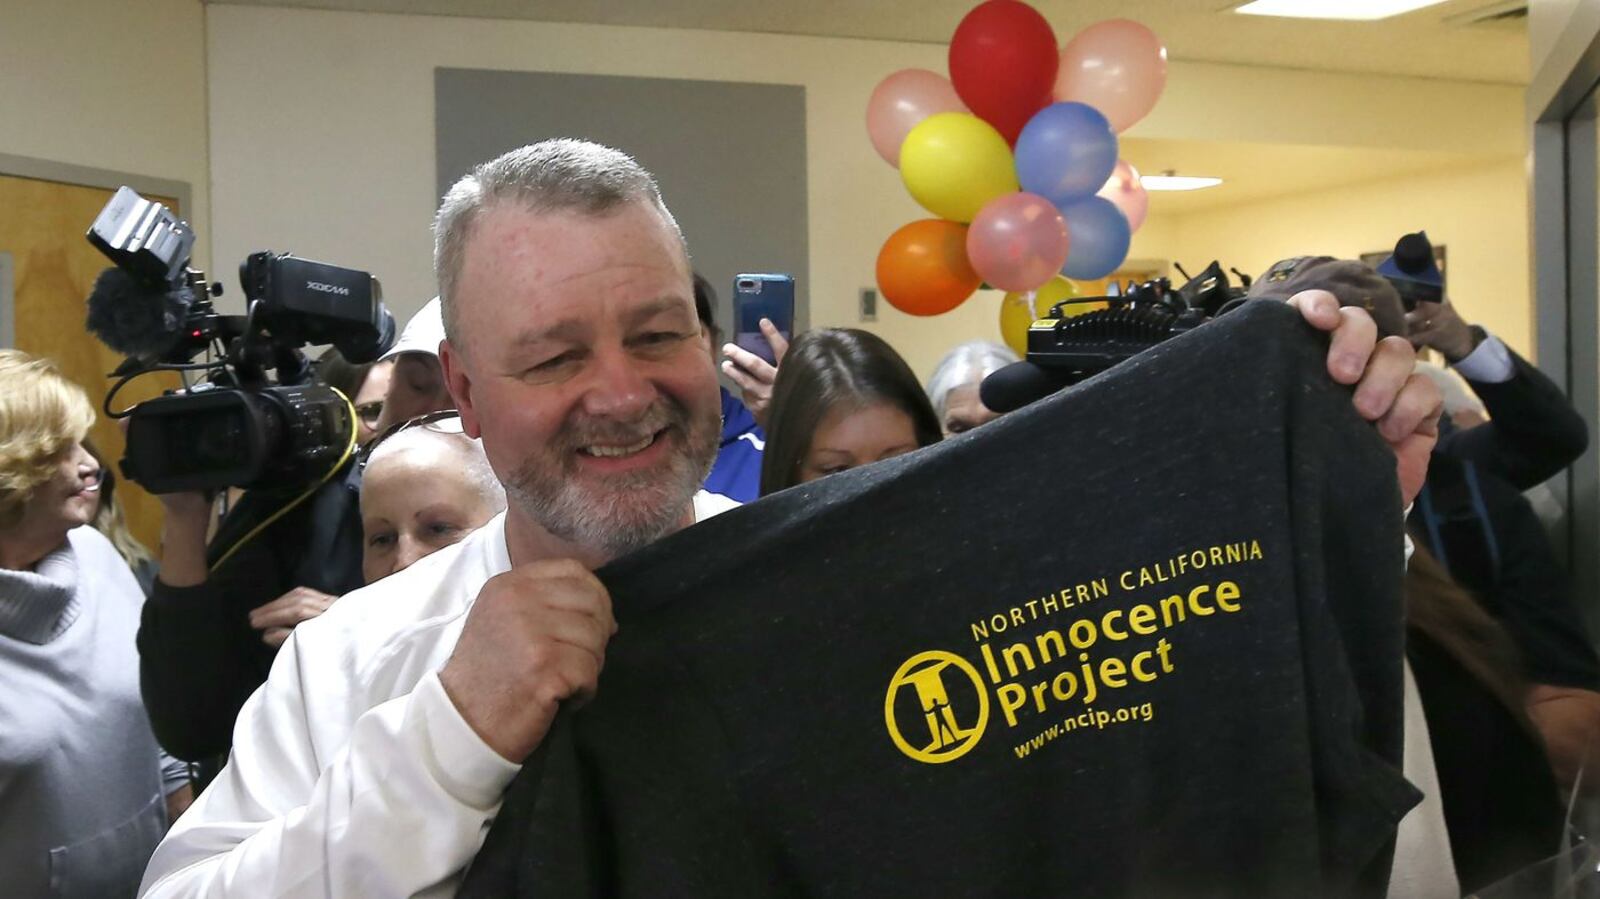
[[979, 262, 1250, 413]]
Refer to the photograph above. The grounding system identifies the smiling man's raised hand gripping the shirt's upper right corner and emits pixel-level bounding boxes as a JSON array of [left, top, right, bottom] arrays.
[[1290, 290, 1445, 505]]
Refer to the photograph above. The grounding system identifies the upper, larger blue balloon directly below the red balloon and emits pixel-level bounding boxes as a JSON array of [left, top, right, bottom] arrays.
[[1016, 102, 1117, 206]]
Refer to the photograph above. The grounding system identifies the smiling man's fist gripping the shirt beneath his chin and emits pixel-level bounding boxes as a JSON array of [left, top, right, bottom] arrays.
[[438, 558, 616, 755]]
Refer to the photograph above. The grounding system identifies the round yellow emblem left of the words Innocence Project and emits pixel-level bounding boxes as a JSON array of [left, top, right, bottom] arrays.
[[883, 649, 989, 765]]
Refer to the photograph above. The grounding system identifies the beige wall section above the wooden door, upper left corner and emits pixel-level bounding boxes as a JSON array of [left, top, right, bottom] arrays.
[[0, 0, 210, 264]]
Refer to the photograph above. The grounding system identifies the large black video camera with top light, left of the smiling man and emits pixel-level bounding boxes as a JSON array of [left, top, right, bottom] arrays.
[[86, 187, 395, 493]]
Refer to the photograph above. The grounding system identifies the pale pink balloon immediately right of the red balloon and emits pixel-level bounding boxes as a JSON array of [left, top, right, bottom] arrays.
[[1056, 19, 1166, 134]]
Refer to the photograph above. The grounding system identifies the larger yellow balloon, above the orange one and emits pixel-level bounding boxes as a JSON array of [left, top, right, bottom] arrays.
[[901, 112, 1018, 222]]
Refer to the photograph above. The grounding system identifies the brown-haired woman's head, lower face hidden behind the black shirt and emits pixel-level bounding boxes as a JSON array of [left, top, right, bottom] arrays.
[[762, 328, 942, 496]]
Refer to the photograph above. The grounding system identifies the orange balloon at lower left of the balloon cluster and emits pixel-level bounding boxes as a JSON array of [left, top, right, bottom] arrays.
[[878, 219, 982, 315]]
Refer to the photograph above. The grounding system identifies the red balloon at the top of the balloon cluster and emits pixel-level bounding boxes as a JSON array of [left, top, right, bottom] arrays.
[[950, 0, 1061, 144]]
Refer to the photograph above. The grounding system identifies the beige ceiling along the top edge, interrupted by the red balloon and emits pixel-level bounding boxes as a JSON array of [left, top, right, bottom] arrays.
[[208, 0, 1528, 85]]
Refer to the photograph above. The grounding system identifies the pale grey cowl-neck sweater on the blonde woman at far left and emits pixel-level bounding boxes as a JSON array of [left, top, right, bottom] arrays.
[[0, 526, 187, 899]]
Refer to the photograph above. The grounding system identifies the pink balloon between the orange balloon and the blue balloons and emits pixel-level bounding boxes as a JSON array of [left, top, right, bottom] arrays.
[[966, 194, 1069, 291]]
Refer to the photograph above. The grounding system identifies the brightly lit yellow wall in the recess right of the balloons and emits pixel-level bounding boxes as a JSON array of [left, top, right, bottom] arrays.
[[1174, 160, 1533, 357]]
